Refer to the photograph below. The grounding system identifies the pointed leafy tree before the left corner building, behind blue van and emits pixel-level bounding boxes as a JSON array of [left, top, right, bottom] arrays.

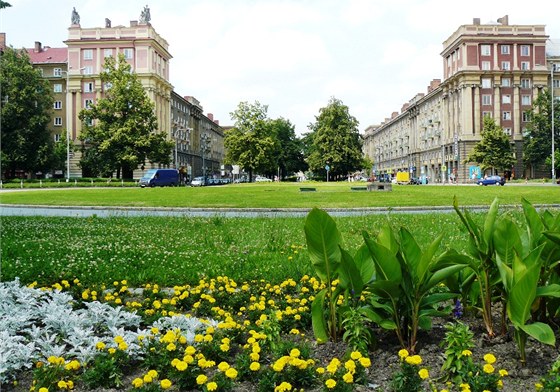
[[79, 54, 174, 178]]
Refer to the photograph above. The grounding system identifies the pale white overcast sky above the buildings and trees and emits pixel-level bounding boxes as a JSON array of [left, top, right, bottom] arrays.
[[0, 0, 560, 135]]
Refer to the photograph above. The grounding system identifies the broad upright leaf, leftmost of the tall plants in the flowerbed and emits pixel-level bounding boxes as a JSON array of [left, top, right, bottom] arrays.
[[304, 208, 342, 284]]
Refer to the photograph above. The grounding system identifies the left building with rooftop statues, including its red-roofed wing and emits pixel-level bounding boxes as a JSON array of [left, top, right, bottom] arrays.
[[24, 7, 224, 178]]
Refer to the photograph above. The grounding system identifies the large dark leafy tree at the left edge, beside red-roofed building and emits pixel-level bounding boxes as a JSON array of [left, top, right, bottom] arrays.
[[0, 47, 54, 178]]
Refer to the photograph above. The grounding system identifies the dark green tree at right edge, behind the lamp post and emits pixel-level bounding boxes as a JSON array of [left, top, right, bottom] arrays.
[[523, 89, 560, 177]]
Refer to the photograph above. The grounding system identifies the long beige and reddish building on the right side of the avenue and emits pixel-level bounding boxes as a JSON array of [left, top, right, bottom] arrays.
[[364, 16, 550, 182]]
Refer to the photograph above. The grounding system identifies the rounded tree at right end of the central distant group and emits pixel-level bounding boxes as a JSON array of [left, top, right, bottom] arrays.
[[306, 97, 364, 177]]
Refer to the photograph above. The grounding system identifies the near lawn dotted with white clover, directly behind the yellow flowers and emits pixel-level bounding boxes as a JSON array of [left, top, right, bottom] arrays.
[[1, 214, 480, 287]]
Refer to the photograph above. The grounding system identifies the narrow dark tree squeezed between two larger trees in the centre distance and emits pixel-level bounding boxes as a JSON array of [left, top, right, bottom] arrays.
[[270, 118, 307, 178]]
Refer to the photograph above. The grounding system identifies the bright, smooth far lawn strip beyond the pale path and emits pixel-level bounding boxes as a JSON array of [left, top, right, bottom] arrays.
[[0, 182, 560, 208]]
